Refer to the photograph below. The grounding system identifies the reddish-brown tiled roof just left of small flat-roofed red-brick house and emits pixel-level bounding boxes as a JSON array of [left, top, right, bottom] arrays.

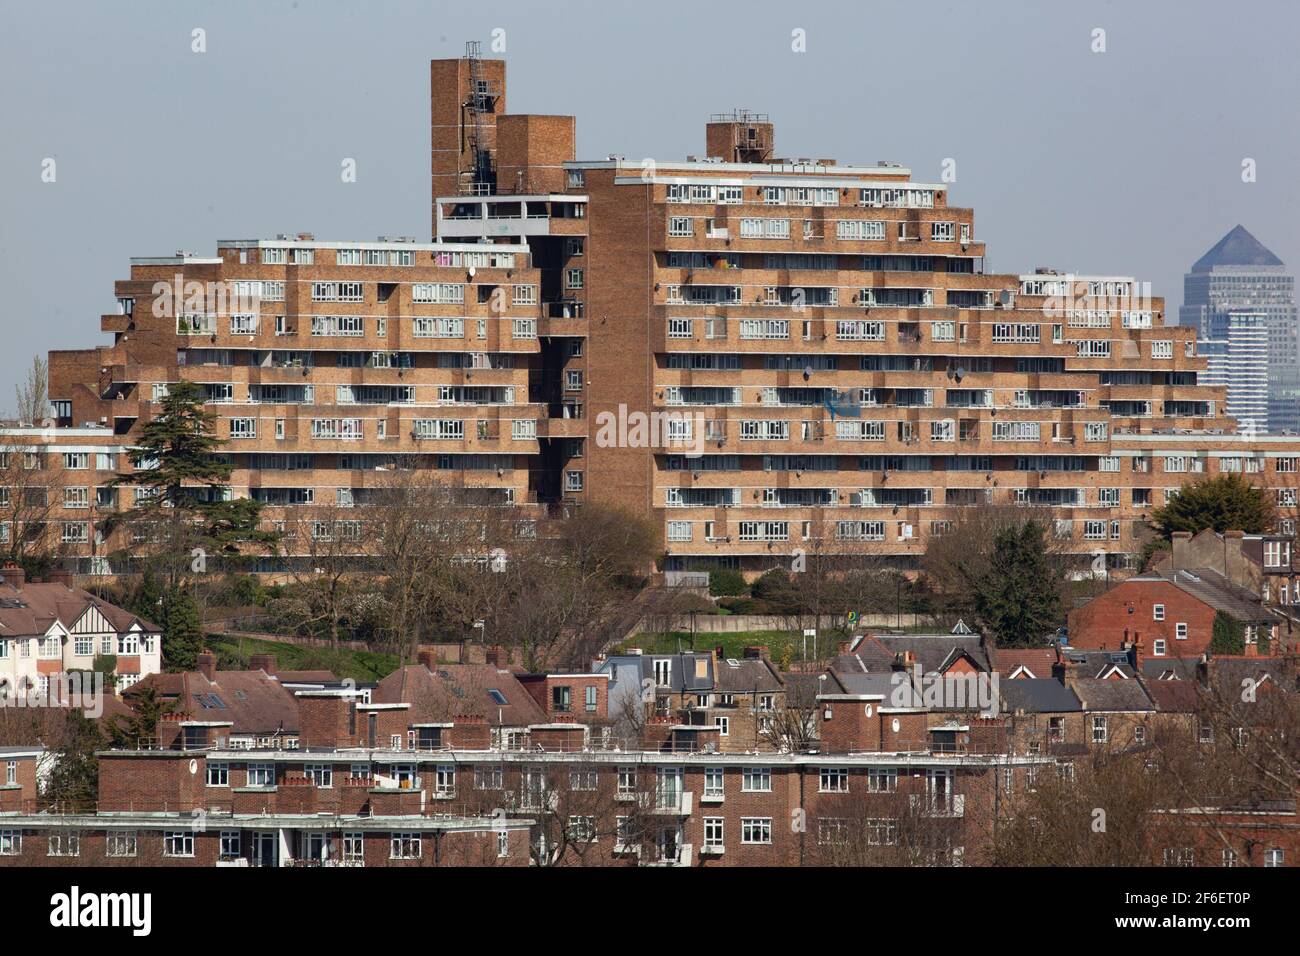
[[371, 663, 547, 727]]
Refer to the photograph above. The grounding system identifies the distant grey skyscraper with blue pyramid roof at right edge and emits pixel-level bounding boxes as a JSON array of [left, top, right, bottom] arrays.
[[1178, 226, 1300, 432]]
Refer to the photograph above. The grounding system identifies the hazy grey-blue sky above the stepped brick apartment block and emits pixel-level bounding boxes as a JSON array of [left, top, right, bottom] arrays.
[[0, 0, 1300, 410]]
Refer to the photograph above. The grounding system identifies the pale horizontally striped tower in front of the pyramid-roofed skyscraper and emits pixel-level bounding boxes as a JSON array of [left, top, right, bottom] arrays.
[[1200, 312, 1270, 433]]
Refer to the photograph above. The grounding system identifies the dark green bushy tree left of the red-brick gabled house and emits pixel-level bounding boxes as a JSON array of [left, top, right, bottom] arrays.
[[959, 520, 1065, 648]]
